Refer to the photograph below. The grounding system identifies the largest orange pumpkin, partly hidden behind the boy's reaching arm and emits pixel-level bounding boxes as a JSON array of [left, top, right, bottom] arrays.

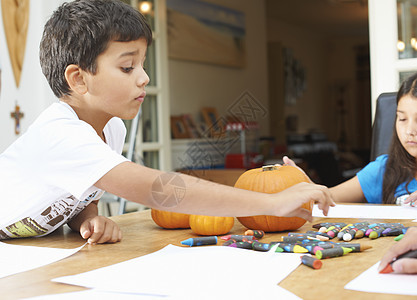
[[235, 165, 314, 232]]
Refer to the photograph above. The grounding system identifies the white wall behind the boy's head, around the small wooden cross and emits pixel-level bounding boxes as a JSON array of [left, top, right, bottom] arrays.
[[0, 0, 63, 152]]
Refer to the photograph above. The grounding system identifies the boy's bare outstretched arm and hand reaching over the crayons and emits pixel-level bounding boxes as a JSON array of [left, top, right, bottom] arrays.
[[95, 162, 334, 220]]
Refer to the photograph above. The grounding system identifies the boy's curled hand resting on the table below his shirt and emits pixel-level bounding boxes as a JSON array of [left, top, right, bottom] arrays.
[[80, 216, 122, 245]]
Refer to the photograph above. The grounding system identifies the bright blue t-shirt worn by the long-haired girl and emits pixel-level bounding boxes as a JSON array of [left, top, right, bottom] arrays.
[[356, 154, 417, 204]]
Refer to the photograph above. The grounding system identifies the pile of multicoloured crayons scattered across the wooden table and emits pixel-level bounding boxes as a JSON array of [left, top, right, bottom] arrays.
[[182, 222, 407, 269]]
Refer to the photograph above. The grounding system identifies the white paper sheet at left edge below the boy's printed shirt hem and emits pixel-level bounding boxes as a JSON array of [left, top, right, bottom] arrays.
[[0, 242, 85, 278]]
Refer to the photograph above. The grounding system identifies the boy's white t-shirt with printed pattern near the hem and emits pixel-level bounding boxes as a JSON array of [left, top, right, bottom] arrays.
[[0, 102, 127, 239]]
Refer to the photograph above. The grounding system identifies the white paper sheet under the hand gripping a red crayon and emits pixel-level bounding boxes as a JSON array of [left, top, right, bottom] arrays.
[[345, 262, 417, 296]]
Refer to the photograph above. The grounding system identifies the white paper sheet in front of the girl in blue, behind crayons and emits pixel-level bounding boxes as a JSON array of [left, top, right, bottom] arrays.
[[313, 204, 417, 219]]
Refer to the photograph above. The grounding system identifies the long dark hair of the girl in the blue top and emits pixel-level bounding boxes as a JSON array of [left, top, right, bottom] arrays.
[[382, 73, 417, 204]]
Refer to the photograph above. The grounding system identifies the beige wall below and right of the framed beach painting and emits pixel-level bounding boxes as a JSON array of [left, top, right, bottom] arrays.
[[169, 0, 269, 134]]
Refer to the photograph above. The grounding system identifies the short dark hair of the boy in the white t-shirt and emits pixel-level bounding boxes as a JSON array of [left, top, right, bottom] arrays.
[[39, 0, 152, 98]]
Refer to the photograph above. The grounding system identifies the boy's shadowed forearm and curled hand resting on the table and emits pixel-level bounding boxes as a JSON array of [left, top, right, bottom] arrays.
[[68, 201, 122, 244]]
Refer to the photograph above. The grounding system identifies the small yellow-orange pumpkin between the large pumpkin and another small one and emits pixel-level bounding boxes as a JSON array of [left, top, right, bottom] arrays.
[[190, 215, 235, 235]]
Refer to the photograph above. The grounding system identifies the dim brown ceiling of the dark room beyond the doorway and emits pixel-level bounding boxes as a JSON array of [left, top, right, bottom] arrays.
[[266, 0, 368, 37]]
